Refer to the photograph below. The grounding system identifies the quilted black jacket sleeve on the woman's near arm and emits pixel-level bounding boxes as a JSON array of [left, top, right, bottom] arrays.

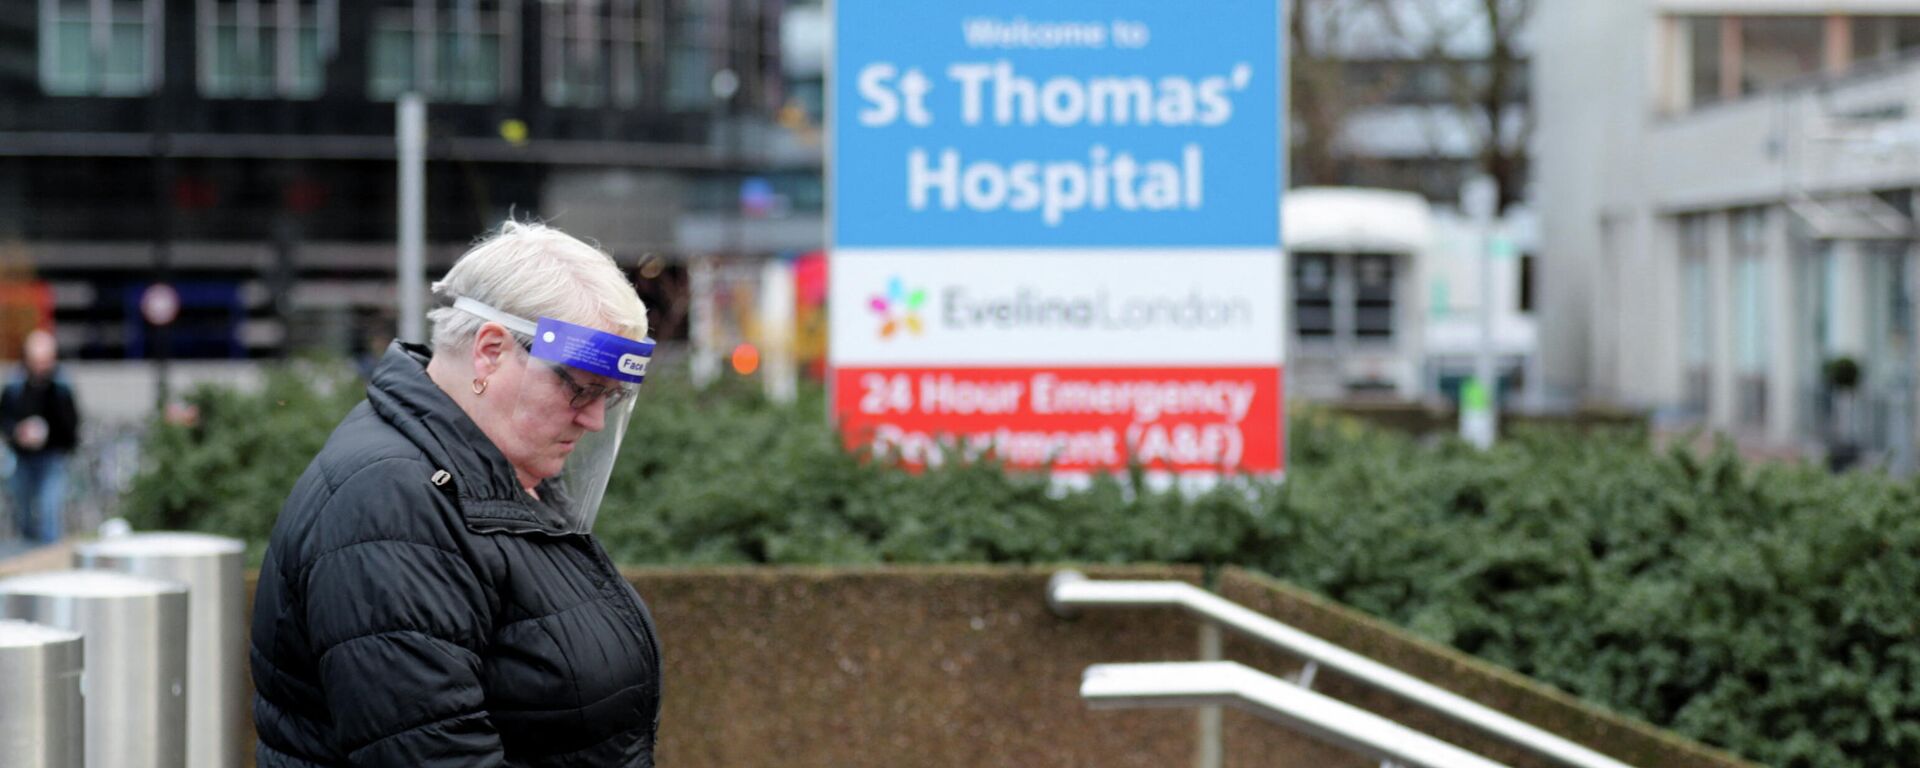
[[303, 461, 505, 768]]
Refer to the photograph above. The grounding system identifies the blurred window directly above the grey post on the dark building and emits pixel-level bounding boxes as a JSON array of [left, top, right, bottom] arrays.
[[367, 0, 520, 104]]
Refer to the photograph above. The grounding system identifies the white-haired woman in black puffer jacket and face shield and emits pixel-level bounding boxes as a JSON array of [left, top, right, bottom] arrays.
[[250, 223, 660, 768]]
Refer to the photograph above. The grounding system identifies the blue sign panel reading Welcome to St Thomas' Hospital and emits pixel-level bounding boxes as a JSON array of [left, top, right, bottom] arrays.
[[831, 0, 1284, 248]]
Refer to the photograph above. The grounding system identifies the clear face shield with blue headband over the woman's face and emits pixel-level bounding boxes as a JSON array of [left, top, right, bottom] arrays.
[[453, 298, 653, 534]]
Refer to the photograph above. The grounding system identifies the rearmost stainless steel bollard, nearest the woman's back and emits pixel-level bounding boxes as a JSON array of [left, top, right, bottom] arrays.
[[73, 532, 252, 768]]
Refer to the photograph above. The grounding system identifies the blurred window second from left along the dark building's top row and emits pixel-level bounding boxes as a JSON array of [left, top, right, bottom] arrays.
[[198, 0, 340, 98]]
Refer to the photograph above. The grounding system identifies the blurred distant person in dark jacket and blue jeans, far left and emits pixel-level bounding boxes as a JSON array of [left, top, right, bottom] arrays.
[[0, 328, 81, 543]]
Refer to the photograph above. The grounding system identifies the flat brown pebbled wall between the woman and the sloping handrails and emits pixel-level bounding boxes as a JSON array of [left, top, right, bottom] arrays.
[[628, 568, 1198, 768]]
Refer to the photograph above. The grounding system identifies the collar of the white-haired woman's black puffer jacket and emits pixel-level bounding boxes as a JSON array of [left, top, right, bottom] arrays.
[[367, 342, 568, 536]]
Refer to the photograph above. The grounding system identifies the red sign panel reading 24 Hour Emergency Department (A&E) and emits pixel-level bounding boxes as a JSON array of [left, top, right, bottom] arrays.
[[833, 367, 1286, 474]]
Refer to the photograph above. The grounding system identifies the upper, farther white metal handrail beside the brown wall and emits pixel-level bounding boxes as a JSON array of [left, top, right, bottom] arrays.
[[1046, 570, 1632, 768]]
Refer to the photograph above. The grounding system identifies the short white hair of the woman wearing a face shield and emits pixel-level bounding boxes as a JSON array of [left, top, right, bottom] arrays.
[[426, 221, 647, 355]]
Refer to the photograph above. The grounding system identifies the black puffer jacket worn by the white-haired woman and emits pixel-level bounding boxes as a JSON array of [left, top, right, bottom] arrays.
[[252, 344, 660, 768]]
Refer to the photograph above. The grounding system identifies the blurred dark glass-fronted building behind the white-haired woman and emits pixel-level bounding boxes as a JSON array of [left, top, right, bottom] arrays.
[[0, 0, 824, 359]]
